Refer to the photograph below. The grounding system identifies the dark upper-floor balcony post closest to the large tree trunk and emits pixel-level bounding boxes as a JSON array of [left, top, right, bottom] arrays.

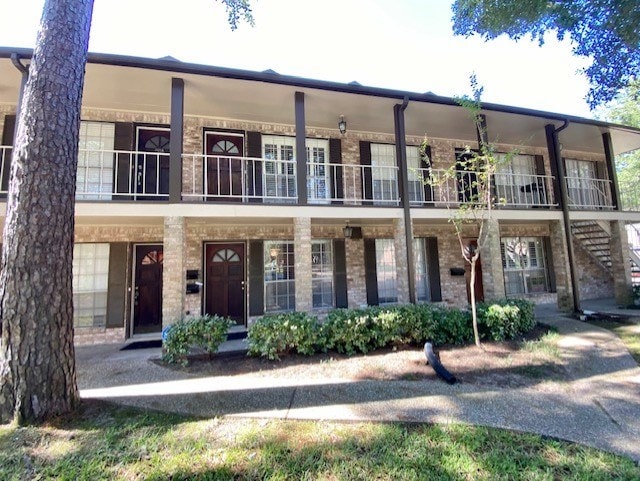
[[169, 77, 184, 203]]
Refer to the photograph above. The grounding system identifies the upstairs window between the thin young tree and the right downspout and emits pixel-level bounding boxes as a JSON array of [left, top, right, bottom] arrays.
[[495, 154, 546, 205]]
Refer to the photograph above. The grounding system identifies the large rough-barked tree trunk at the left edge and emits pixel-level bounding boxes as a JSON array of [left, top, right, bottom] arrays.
[[0, 0, 93, 422]]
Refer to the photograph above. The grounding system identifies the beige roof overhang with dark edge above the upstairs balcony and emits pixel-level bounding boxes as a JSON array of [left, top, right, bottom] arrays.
[[0, 48, 640, 154]]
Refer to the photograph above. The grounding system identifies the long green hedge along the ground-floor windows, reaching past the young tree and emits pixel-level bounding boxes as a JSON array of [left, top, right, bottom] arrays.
[[248, 299, 535, 360]]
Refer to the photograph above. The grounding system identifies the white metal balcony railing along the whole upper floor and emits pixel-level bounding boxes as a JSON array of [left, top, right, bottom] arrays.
[[0, 146, 640, 211]]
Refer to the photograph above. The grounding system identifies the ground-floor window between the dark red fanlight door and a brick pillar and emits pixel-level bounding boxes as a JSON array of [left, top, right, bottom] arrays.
[[264, 241, 296, 312]]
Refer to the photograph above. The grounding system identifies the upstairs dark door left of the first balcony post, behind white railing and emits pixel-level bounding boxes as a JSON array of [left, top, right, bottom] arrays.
[[134, 127, 171, 200]]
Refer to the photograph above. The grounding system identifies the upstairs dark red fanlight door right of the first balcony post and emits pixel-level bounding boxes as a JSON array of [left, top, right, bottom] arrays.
[[205, 132, 244, 202]]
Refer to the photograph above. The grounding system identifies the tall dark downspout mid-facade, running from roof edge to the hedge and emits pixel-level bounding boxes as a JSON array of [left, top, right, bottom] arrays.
[[394, 96, 416, 304]]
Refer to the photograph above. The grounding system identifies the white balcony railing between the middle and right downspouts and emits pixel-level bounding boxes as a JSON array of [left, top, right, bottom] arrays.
[[409, 169, 557, 208]]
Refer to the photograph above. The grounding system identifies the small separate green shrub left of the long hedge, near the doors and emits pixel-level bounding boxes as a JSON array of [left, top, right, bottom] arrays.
[[162, 314, 233, 365]]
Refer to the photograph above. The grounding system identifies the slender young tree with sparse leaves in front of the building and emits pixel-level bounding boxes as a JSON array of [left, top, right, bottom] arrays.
[[420, 80, 513, 346]]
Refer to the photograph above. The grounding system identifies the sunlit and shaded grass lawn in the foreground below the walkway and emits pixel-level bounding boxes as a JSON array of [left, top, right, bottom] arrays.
[[0, 401, 640, 481]]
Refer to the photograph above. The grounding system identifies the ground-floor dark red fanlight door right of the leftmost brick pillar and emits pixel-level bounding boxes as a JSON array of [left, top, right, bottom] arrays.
[[205, 244, 245, 325]]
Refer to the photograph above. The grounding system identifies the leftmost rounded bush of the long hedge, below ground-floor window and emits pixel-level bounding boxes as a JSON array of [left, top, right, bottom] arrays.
[[247, 312, 325, 360]]
